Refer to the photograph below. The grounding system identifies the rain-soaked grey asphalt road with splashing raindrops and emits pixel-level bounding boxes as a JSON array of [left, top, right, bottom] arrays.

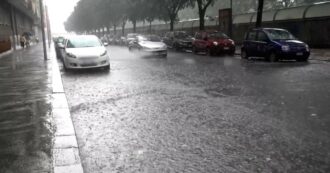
[[62, 47, 330, 173]]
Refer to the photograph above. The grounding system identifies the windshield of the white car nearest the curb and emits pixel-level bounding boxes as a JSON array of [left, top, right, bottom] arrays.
[[67, 37, 102, 48]]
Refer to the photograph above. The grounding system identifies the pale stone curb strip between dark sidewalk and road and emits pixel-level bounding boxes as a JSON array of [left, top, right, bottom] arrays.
[[51, 48, 84, 173]]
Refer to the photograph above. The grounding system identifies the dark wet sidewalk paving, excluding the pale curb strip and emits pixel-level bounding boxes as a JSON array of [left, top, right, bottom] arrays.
[[0, 44, 54, 173]]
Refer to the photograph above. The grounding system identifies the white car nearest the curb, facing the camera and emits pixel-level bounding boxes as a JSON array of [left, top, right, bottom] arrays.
[[61, 35, 110, 70]]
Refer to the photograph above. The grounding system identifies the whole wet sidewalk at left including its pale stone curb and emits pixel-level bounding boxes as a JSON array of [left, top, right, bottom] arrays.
[[0, 44, 83, 173]]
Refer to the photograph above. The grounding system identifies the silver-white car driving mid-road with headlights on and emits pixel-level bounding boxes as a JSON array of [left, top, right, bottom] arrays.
[[128, 35, 167, 57]]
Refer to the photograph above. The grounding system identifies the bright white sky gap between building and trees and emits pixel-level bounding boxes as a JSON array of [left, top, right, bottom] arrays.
[[44, 0, 79, 33]]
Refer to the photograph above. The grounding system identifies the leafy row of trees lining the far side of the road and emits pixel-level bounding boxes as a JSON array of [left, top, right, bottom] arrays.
[[65, 0, 324, 33]]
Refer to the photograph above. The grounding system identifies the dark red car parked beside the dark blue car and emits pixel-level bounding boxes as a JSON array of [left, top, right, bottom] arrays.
[[193, 31, 235, 56]]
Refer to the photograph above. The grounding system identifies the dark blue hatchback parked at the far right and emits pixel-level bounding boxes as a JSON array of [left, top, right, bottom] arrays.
[[241, 28, 310, 62]]
